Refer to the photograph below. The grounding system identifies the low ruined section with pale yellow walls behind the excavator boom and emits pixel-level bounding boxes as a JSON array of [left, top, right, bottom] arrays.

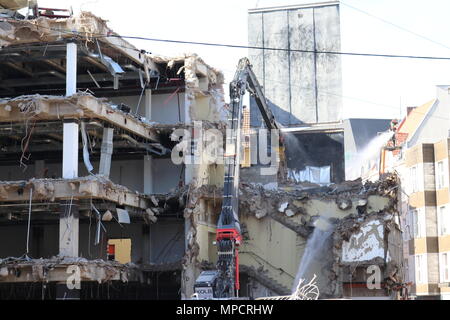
[[183, 176, 403, 299]]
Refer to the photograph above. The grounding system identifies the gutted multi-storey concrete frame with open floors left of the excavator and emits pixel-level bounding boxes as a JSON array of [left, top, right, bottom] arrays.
[[0, 13, 227, 298]]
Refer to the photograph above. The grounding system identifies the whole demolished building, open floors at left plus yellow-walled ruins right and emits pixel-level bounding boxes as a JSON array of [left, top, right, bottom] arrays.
[[0, 8, 403, 299]]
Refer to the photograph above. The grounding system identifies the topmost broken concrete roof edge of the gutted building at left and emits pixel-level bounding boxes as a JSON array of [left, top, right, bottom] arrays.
[[0, 11, 224, 93]]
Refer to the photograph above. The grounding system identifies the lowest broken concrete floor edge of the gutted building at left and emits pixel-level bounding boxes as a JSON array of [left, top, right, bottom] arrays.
[[0, 257, 181, 284]]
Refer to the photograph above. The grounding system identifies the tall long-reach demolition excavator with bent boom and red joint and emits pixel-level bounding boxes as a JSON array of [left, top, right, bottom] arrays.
[[194, 58, 279, 299]]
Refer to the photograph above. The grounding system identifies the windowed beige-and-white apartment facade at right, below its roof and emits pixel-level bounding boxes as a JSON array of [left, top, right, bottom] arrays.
[[404, 139, 450, 299]]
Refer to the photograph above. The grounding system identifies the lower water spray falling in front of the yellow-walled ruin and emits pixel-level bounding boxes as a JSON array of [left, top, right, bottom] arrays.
[[292, 217, 334, 293]]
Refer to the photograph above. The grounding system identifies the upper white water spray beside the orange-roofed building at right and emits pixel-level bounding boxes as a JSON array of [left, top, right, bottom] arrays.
[[346, 131, 394, 180]]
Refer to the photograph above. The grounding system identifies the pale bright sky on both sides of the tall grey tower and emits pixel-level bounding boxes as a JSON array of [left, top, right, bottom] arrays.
[[39, 0, 450, 118]]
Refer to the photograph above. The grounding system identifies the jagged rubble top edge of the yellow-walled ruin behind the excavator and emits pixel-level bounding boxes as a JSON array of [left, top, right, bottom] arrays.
[[187, 174, 398, 234]]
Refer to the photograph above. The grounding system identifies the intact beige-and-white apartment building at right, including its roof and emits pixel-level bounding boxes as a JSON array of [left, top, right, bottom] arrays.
[[381, 86, 450, 299]]
